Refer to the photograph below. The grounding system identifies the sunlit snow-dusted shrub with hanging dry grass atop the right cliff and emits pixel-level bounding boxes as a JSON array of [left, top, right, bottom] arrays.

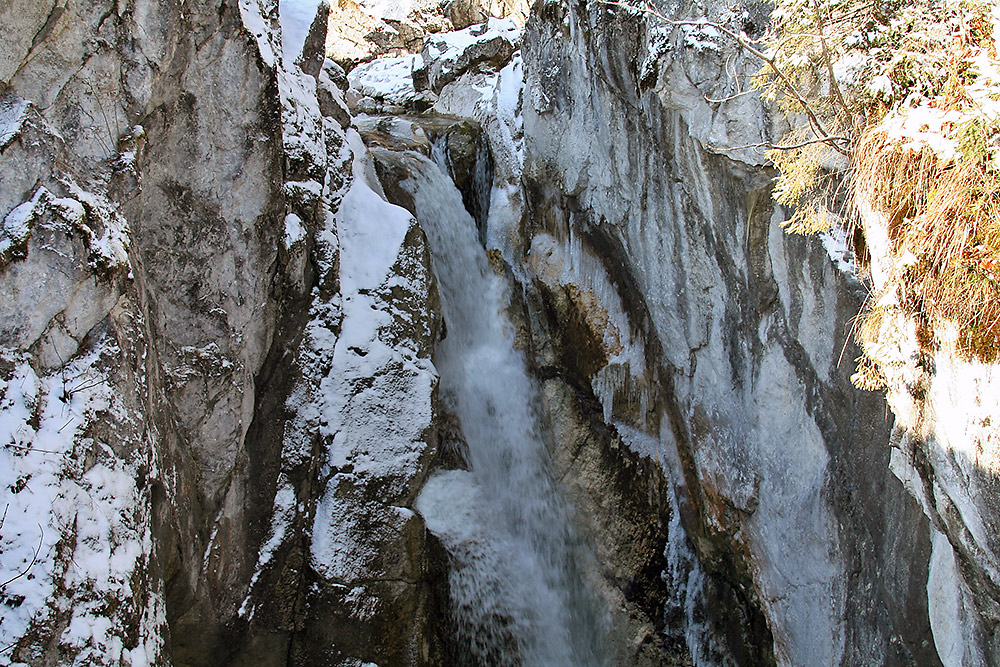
[[757, 0, 1000, 370]]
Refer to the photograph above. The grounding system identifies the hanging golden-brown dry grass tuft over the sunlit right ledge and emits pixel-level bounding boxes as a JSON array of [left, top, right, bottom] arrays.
[[852, 127, 1000, 361]]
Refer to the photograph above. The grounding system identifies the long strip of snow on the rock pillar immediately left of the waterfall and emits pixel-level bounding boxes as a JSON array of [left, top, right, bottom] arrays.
[[312, 130, 437, 582]]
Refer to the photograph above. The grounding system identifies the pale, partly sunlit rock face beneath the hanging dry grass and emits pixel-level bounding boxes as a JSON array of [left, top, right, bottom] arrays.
[[864, 213, 1000, 665]]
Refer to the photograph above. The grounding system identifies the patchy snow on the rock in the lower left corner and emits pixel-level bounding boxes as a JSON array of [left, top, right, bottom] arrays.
[[0, 338, 165, 665]]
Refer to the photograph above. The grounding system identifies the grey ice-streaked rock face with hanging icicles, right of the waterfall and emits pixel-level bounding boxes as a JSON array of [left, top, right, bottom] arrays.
[[507, 2, 938, 664]]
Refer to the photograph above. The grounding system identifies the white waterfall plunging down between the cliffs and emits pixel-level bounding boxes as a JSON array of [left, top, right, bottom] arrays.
[[400, 153, 605, 667]]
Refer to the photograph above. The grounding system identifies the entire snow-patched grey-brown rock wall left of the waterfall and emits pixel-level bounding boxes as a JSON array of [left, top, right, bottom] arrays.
[[0, 0, 440, 665]]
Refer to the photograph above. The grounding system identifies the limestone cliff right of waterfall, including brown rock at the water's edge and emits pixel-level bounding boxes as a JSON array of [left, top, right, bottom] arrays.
[[342, 2, 937, 664]]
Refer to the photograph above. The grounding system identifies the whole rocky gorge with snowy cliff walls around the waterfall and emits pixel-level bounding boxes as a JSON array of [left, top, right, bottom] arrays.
[[0, 0, 1000, 667]]
